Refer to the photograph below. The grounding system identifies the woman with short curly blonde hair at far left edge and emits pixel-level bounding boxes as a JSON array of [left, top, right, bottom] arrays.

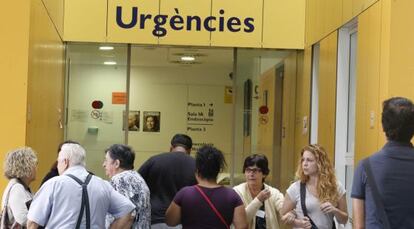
[[1, 147, 37, 228]]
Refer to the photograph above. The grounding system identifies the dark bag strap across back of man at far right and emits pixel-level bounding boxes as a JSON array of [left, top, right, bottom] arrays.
[[362, 158, 391, 229]]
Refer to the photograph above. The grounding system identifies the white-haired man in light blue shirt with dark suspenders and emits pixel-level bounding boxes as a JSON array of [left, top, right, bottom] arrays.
[[27, 143, 135, 229]]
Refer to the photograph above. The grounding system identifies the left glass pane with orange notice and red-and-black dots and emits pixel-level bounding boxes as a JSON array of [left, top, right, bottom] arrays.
[[66, 44, 127, 177]]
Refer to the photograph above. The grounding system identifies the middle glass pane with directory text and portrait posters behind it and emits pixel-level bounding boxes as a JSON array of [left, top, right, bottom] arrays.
[[128, 46, 233, 172]]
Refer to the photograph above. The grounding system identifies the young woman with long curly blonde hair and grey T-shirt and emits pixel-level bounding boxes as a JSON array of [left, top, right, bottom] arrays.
[[281, 144, 348, 229]]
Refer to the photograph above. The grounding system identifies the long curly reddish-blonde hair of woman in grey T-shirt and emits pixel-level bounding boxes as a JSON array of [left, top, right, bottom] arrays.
[[296, 144, 339, 204]]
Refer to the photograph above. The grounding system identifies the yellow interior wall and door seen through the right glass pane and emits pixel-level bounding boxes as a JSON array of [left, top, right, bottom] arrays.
[[257, 52, 298, 192]]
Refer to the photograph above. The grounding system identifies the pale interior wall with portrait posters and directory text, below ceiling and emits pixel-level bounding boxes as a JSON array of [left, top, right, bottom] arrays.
[[128, 67, 232, 165]]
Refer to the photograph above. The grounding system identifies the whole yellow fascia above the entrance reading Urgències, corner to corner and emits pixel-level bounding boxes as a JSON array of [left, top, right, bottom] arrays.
[[100, 0, 305, 49]]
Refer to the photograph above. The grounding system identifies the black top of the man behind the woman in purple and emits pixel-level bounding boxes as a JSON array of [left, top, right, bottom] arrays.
[[138, 152, 197, 224]]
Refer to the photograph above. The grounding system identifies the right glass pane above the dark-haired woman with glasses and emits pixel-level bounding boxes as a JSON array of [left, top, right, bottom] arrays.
[[233, 49, 296, 188]]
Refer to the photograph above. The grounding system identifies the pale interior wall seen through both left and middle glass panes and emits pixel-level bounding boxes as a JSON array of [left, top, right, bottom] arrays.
[[67, 64, 233, 176]]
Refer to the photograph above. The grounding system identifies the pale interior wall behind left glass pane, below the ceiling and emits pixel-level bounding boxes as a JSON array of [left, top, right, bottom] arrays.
[[66, 65, 126, 177]]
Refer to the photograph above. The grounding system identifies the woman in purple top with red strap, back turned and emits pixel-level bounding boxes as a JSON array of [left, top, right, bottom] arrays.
[[166, 146, 247, 229]]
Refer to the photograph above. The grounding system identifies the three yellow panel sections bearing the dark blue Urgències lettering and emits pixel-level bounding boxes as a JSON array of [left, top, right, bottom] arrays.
[[107, 0, 263, 47]]
